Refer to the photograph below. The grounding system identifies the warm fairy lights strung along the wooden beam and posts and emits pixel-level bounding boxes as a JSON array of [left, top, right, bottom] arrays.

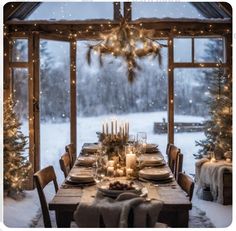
[[4, 4, 232, 122]]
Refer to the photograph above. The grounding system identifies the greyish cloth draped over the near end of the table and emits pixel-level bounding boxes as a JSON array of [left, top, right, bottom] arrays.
[[74, 183, 163, 227]]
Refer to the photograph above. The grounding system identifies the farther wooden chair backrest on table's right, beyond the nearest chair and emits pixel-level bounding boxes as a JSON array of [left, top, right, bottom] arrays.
[[168, 144, 183, 180]]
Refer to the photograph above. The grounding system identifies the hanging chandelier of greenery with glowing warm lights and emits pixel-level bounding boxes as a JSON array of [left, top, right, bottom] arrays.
[[87, 19, 162, 83]]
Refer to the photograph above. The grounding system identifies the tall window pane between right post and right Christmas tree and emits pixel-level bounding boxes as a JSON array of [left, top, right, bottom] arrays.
[[174, 68, 216, 174]]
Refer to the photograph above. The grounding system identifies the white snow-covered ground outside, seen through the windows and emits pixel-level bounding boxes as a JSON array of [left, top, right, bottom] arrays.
[[40, 112, 204, 184]]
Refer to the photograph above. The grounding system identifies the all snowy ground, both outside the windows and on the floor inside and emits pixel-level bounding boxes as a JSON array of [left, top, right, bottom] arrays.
[[4, 112, 232, 227]]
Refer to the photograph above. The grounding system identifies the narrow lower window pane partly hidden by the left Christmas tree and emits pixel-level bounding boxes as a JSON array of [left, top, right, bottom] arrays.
[[12, 68, 29, 156]]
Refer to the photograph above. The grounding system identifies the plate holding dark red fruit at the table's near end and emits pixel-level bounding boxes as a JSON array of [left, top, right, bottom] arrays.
[[97, 181, 144, 198]]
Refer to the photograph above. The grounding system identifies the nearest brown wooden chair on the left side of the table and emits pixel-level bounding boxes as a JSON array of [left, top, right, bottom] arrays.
[[34, 166, 58, 228]]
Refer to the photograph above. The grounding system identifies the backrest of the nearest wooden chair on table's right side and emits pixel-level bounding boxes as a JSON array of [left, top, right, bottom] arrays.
[[178, 172, 194, 201]]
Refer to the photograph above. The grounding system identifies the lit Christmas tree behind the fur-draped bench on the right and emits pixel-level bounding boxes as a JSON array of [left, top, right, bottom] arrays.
[[195, 63, 232, 159]]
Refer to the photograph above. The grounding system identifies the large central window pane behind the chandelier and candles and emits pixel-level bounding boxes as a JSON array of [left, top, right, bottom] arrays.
[[77, 40, 167, 155]]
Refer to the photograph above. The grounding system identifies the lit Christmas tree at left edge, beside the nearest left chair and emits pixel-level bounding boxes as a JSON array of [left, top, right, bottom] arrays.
[[3, 97, 31, 198]]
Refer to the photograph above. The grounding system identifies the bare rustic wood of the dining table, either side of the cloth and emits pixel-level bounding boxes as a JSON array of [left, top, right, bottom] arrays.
[[49, 144, 192, 227]]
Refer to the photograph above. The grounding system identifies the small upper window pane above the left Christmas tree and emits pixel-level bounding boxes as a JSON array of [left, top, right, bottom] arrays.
[[12, 39, 28, 62]]
